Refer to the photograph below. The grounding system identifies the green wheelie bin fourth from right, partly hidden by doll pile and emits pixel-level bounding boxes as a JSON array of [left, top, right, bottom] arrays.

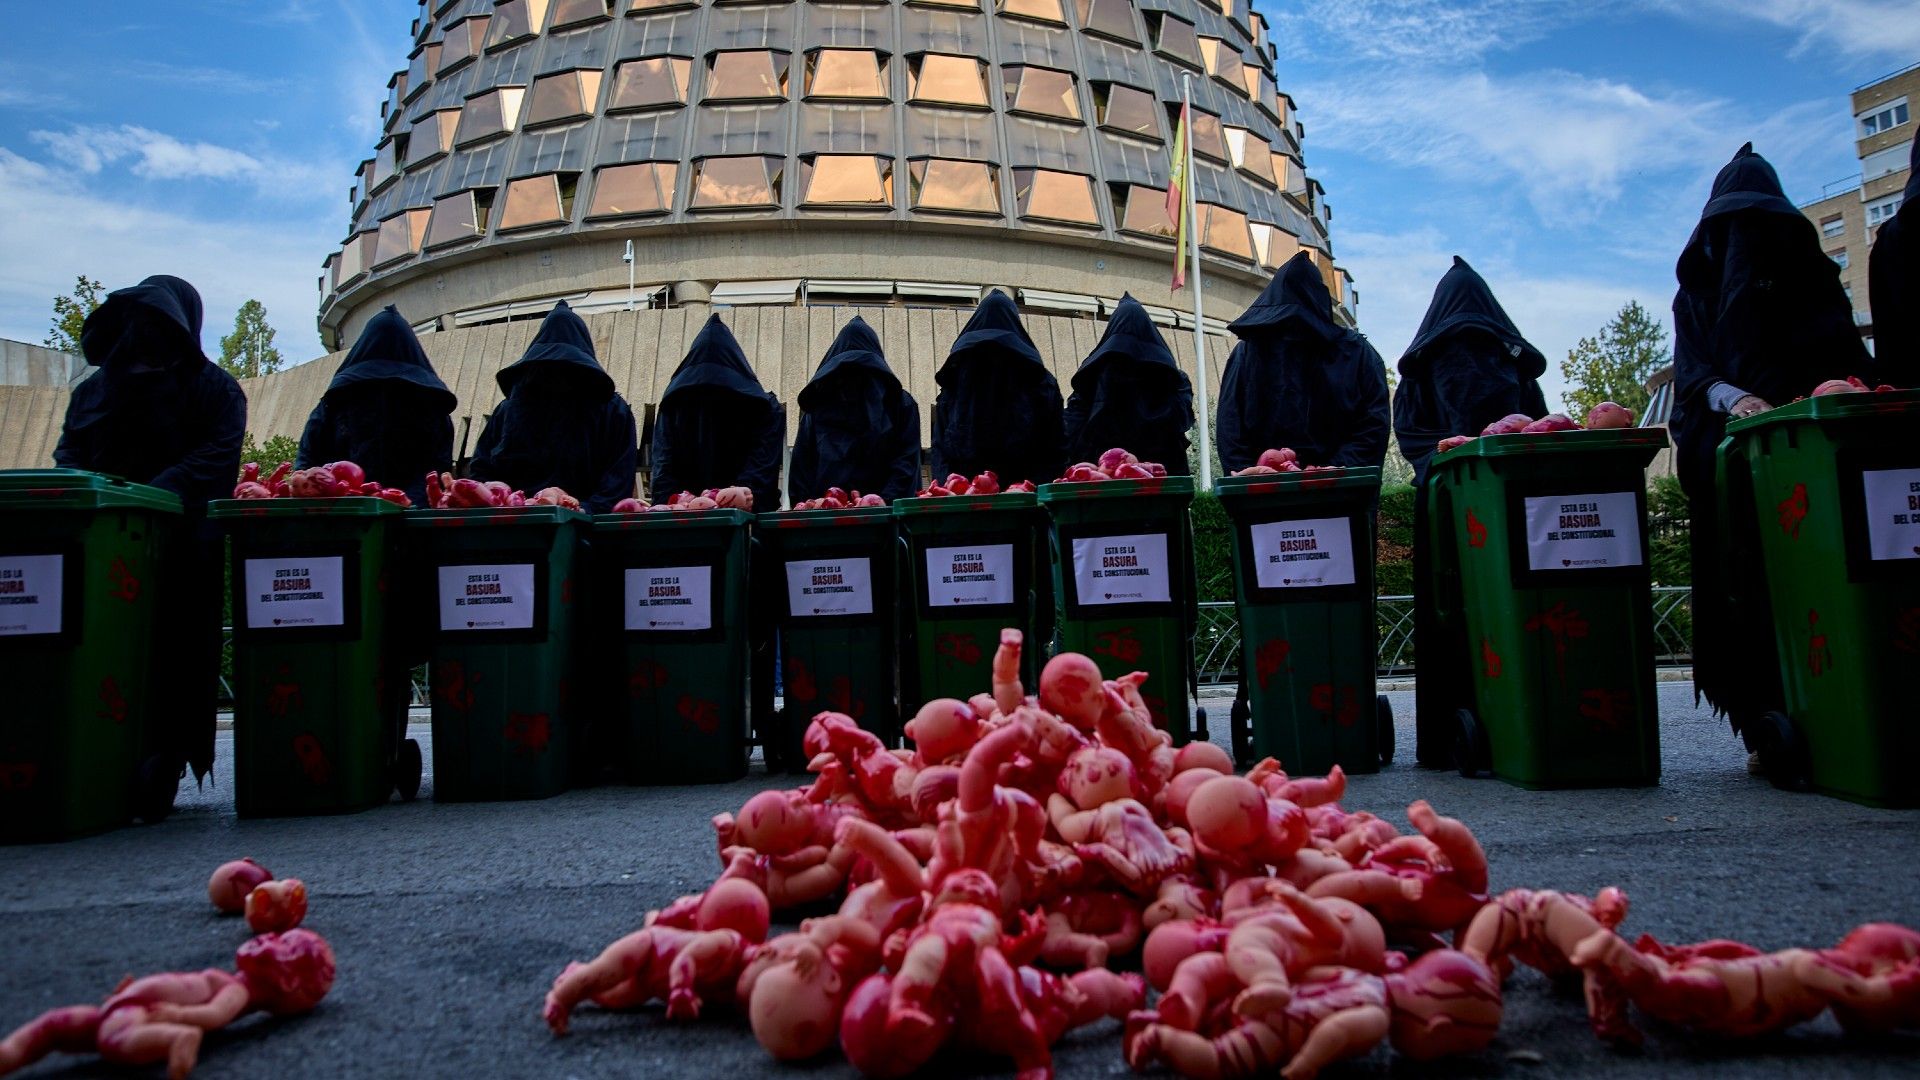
[[1039, 477, 1206, 746]]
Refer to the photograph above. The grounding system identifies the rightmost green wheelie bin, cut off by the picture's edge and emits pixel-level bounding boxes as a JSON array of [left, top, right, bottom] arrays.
[[1718, 390, 1920, 807]]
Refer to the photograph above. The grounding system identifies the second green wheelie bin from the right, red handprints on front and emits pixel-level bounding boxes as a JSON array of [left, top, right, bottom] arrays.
[[1417, 429, 1667, 788]]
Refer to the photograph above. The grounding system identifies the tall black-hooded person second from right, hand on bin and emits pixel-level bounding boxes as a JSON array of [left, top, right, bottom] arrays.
[[1670, 142, 1866, 730]]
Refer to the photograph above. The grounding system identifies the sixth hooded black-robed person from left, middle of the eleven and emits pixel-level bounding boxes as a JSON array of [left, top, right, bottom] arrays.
[[933, 288, 1067, 486]]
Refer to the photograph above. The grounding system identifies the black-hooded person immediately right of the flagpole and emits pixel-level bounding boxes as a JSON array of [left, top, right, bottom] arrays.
[[1215, 252, 1390, 473]]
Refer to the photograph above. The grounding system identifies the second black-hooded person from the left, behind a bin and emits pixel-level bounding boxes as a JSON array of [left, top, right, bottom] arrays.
[[294, 307, 455, 505]]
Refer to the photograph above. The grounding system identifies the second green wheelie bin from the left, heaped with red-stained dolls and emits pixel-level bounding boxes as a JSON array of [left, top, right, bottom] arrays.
[[207, 498, 420, 817]]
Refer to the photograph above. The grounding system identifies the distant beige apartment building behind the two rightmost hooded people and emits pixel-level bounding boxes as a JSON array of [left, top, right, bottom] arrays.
[[1801, 63, 1920, 348]]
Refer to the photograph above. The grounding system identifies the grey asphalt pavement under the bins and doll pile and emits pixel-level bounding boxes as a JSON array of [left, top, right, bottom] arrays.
[[0, 682, 1920, 1080]]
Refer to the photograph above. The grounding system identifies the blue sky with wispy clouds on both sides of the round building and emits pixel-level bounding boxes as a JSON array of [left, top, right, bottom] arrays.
[[0, 0, 1920, 400]]
